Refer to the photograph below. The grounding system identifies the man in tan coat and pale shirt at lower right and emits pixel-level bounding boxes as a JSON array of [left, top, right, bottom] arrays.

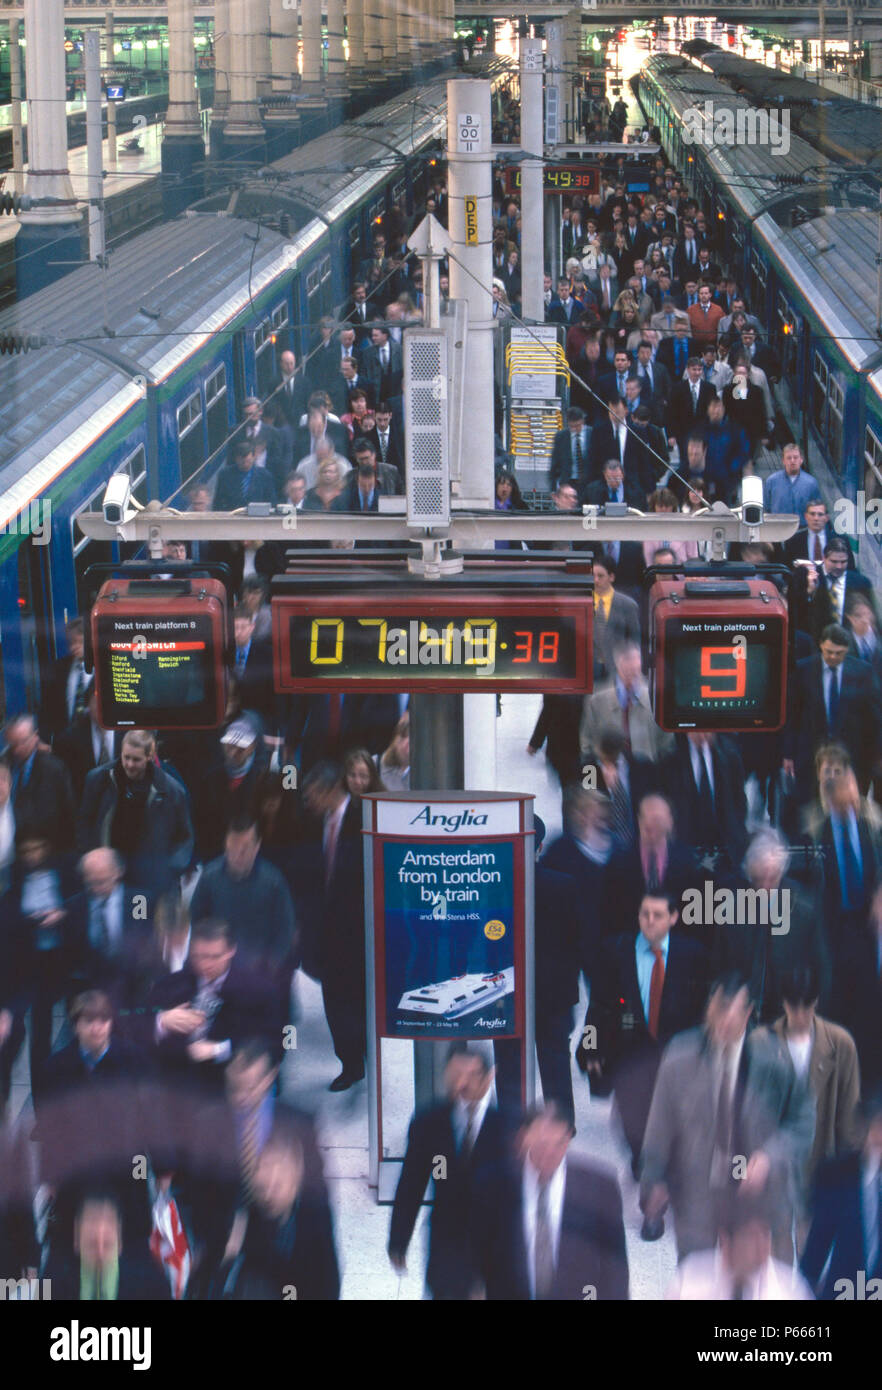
[[774, 965, 861, 1252]]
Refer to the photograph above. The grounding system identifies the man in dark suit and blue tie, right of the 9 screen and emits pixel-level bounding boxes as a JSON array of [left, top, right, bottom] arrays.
[[783, 623, 882, 805]]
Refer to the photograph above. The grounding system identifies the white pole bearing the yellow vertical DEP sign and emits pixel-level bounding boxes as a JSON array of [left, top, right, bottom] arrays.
[[447, 78, 494, 509]]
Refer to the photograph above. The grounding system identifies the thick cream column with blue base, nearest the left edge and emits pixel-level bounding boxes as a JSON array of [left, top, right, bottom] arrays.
[[15, 0, 82, 299]]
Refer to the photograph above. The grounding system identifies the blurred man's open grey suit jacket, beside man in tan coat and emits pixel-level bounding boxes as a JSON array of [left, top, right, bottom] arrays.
[[640, 1027, 815, 1259]]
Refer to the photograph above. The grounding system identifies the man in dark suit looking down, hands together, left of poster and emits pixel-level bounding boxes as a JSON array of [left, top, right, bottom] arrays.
[[150, 919, 285, 1091]]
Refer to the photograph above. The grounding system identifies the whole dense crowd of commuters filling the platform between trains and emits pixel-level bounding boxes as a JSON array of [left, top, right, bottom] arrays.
[[0, 95, 882, 1300]]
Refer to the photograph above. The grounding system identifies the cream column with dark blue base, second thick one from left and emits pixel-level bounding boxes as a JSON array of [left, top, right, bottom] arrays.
[[163, 0, 206, 217]]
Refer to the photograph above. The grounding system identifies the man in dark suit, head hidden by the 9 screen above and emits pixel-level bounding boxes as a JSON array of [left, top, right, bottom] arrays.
[[658, 733, 747, 872]]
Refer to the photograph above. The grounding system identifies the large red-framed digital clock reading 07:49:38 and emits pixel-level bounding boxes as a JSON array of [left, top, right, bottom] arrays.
[[272, 591, 592, 694]]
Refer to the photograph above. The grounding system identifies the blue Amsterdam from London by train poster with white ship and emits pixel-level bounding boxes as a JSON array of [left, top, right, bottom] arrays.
[[383, 840, 515, 1038]]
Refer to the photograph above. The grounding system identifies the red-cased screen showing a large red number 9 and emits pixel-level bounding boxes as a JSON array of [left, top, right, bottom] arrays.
[[649, 578, 788, 733]]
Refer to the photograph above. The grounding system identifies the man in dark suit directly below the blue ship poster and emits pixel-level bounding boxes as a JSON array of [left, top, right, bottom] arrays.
[[389, 1048, 513, 1298]]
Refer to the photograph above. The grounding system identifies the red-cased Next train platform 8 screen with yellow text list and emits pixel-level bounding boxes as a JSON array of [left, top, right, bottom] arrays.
[[92, 580, 226, 730]]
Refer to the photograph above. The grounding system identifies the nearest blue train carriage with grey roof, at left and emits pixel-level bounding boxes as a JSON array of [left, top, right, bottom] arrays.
[[0, 217, 304, 709]]
